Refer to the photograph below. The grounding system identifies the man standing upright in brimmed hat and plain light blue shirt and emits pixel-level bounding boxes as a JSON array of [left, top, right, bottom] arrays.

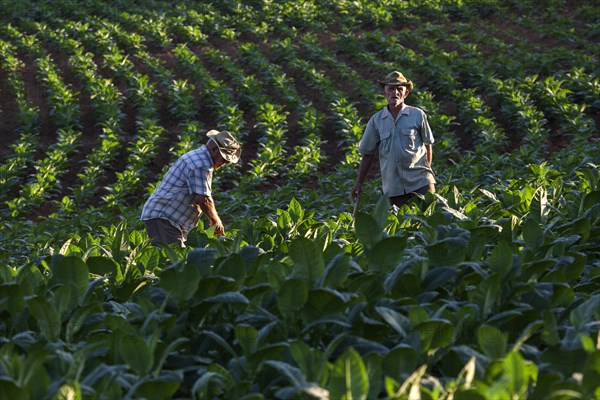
[[351, 71, 435, 207]]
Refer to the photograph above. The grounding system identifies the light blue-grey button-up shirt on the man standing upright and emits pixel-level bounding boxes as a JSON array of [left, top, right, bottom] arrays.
[[358, 104, 435, 197]]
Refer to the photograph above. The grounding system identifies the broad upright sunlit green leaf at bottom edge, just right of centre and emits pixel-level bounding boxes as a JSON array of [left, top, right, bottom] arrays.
[[327, 349, 369, 400]]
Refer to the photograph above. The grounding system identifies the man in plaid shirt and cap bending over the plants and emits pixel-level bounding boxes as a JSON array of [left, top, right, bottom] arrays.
[[141, 130, 242, 247]]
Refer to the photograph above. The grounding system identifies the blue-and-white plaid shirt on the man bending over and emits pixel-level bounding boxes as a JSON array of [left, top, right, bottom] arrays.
[[141, 146, 214, 235]]
